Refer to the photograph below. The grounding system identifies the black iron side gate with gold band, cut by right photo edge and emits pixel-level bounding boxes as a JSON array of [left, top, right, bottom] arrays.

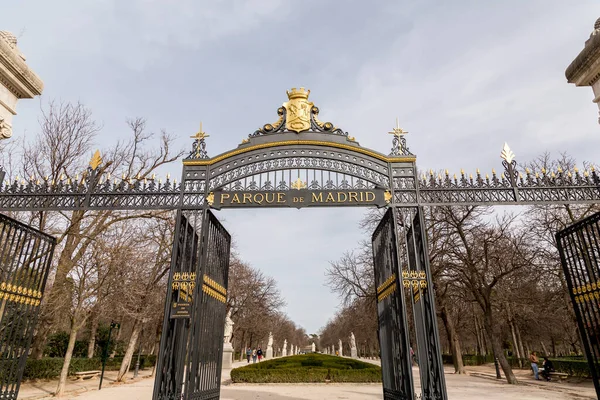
[[556, 213, 600, 398]]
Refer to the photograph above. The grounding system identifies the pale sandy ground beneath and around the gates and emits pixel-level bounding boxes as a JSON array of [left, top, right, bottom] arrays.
[[19, 363, 596, 400]]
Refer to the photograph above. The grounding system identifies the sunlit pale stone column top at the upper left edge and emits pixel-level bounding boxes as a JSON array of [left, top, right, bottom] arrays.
[[0, 31, 44, 140]]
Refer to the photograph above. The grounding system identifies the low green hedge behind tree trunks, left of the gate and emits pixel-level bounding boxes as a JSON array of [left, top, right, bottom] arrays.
[[12, 354, 156, 379]]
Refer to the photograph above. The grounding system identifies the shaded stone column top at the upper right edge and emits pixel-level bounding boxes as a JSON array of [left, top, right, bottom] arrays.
[[565, 18, 600, 123]]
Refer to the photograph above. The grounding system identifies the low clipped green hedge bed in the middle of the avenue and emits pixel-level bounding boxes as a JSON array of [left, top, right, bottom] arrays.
[[231, 354, 381, 383]]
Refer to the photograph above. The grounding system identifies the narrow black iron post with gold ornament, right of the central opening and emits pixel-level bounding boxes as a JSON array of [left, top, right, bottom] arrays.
[[402, 208, 448, 400]]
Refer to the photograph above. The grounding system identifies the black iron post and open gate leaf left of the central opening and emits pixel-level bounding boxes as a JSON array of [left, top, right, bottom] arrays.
[[153, 210, 231, 400]]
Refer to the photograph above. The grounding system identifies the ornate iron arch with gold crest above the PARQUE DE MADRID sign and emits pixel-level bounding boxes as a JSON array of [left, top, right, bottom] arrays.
[[183, 88, 416, 208]]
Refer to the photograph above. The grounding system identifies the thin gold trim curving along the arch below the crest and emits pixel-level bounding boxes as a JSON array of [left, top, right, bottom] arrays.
[[183, 140, 417, 165]]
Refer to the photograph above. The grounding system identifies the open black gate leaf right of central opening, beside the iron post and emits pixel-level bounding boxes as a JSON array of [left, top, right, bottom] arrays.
[[372, 208, 415, 400]]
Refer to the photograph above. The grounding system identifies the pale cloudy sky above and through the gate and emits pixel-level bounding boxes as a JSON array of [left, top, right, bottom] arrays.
[[0, 0, 600, 333]]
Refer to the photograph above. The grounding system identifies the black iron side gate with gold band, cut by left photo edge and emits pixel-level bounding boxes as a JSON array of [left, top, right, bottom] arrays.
[[0, 214, 56, 400]]
